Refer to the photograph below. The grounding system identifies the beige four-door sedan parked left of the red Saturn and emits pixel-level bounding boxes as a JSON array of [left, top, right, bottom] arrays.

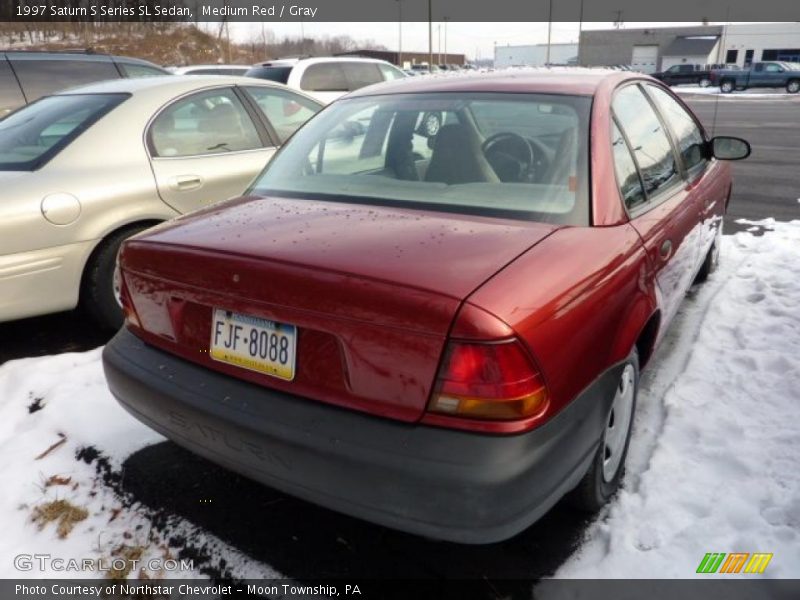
[[0, 75, 321, 327]]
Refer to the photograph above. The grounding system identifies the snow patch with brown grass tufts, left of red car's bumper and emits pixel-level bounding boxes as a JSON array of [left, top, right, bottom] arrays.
[[0, 349, 277, 578]]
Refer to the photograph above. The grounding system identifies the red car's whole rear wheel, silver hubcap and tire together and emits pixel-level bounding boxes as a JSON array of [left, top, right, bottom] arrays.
[[568, 349, 639, 512]]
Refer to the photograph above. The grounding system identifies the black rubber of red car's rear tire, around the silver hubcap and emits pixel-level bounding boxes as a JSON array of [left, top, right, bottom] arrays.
[[567, 348, 639, 512]]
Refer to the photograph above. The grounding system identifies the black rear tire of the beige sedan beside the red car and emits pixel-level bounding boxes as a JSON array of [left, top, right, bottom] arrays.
[[80, 226, 147, 330]]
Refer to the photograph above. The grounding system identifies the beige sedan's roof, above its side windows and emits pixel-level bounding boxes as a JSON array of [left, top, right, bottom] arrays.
[[56, 75, 319, 103]]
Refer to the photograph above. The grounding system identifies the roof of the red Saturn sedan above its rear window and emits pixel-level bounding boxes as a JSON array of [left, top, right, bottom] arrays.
[[348, 67, 644, 98]]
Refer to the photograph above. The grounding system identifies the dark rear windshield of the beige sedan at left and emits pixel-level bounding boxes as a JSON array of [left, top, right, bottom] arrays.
[[0, 94, 128, 171]]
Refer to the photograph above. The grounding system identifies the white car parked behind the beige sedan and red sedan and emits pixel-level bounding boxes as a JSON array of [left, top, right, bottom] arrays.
[[246, 56, 406, 104]]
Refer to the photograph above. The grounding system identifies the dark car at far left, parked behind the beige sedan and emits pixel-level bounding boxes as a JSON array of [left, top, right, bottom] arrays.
[[0, 51, 170, 118]]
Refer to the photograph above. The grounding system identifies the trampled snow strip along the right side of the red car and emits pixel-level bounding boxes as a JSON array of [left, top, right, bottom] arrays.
[[555, 220, 800, 579]]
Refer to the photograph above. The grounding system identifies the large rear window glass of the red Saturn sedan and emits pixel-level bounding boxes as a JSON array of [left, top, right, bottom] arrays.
[[251, 93, 591, 225]]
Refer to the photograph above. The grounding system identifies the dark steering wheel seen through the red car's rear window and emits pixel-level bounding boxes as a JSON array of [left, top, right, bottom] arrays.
[[481, 131, 550, 183]]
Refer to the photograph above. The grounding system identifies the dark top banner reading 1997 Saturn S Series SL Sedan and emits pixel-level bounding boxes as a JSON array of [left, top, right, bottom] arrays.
[[0, 0, 800, 23]]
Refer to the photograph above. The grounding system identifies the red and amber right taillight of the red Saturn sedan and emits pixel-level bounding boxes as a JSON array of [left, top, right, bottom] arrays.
[[428, 339, 547, 421]]
